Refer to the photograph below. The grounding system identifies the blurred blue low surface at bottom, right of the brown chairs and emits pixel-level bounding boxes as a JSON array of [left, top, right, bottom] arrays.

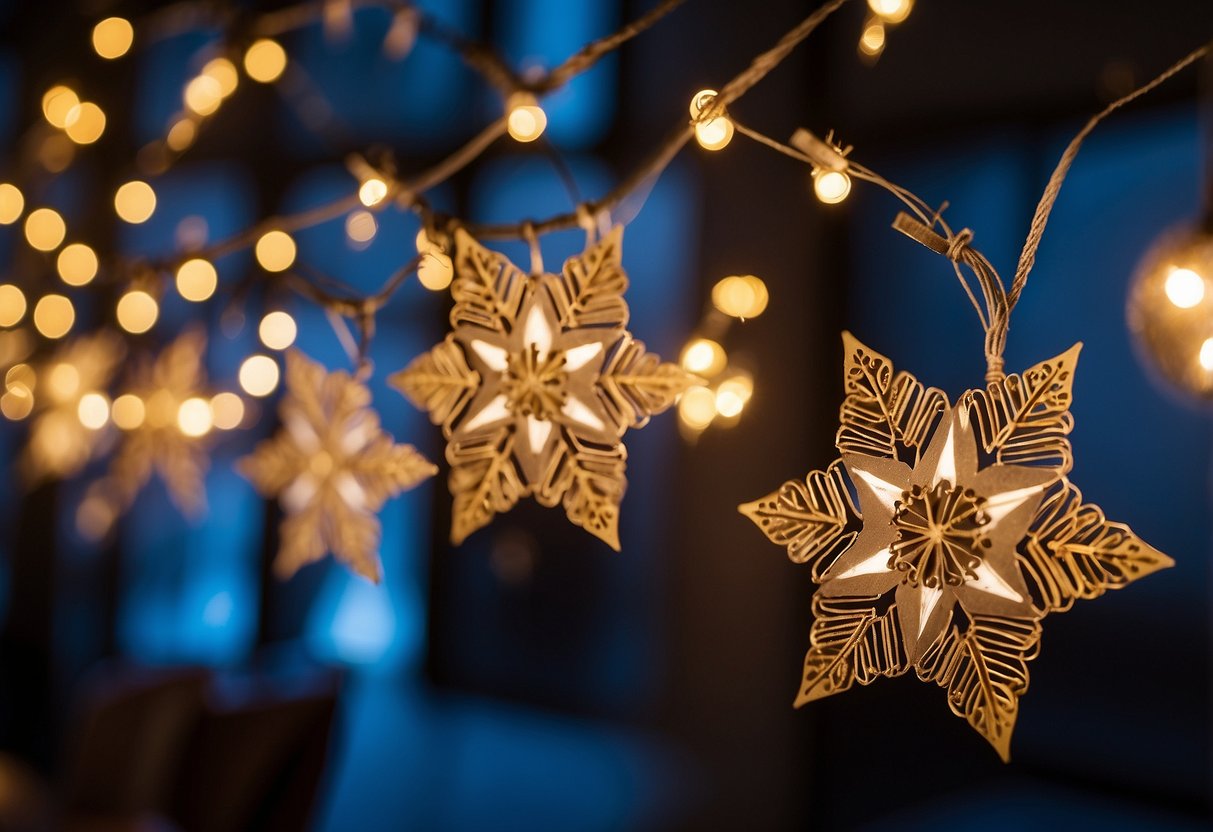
[[317, 682, 688, 832]]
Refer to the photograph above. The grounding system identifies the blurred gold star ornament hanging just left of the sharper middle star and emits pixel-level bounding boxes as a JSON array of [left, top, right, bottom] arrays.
[[239, 351, 438, 581]]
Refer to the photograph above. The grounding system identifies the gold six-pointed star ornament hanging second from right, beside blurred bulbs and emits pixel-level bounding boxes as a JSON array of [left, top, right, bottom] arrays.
[[391, 227, 699, 551]]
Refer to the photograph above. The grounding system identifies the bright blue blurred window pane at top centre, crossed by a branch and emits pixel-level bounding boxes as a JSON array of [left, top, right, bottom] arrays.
[[494, 0, 620, 148]]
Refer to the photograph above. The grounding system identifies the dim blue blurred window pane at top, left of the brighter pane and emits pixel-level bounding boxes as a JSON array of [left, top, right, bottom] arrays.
[[287, 0, 479, 152]]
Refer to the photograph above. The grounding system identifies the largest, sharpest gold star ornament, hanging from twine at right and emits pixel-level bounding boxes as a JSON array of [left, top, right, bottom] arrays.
[[740, 334, 1173, 760]]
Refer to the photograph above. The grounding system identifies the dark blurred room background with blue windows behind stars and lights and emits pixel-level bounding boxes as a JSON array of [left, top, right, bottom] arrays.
[[0, 0, 1213, 830]]
